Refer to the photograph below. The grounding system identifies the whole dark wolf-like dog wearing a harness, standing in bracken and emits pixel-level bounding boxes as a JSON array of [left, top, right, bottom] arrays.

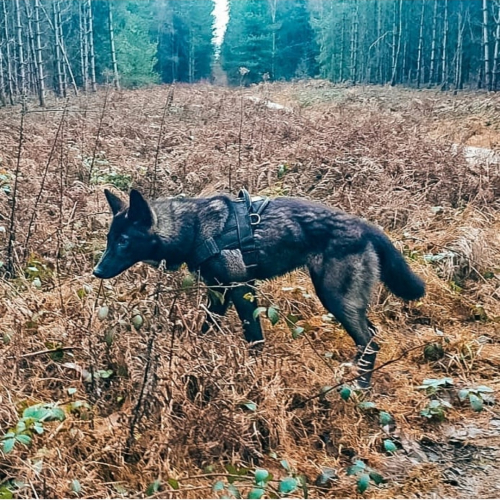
[[94, 190, 425, 387]]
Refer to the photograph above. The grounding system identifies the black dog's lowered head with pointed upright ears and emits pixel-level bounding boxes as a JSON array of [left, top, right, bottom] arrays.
[[94, 189, 157, 279]]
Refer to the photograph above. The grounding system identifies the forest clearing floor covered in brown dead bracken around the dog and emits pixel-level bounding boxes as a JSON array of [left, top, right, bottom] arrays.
[[0, 81, 500, 498]]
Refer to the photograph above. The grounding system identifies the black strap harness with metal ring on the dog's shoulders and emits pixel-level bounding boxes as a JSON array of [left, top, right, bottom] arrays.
[[192, 189, 269, 269]]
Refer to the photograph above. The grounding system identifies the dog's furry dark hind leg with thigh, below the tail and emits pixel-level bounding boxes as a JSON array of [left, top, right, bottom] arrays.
[[309, 252, 379, 387]]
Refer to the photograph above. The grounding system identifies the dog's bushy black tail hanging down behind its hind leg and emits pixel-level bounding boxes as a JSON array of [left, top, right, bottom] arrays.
[[371, 228, 425, 300]]
